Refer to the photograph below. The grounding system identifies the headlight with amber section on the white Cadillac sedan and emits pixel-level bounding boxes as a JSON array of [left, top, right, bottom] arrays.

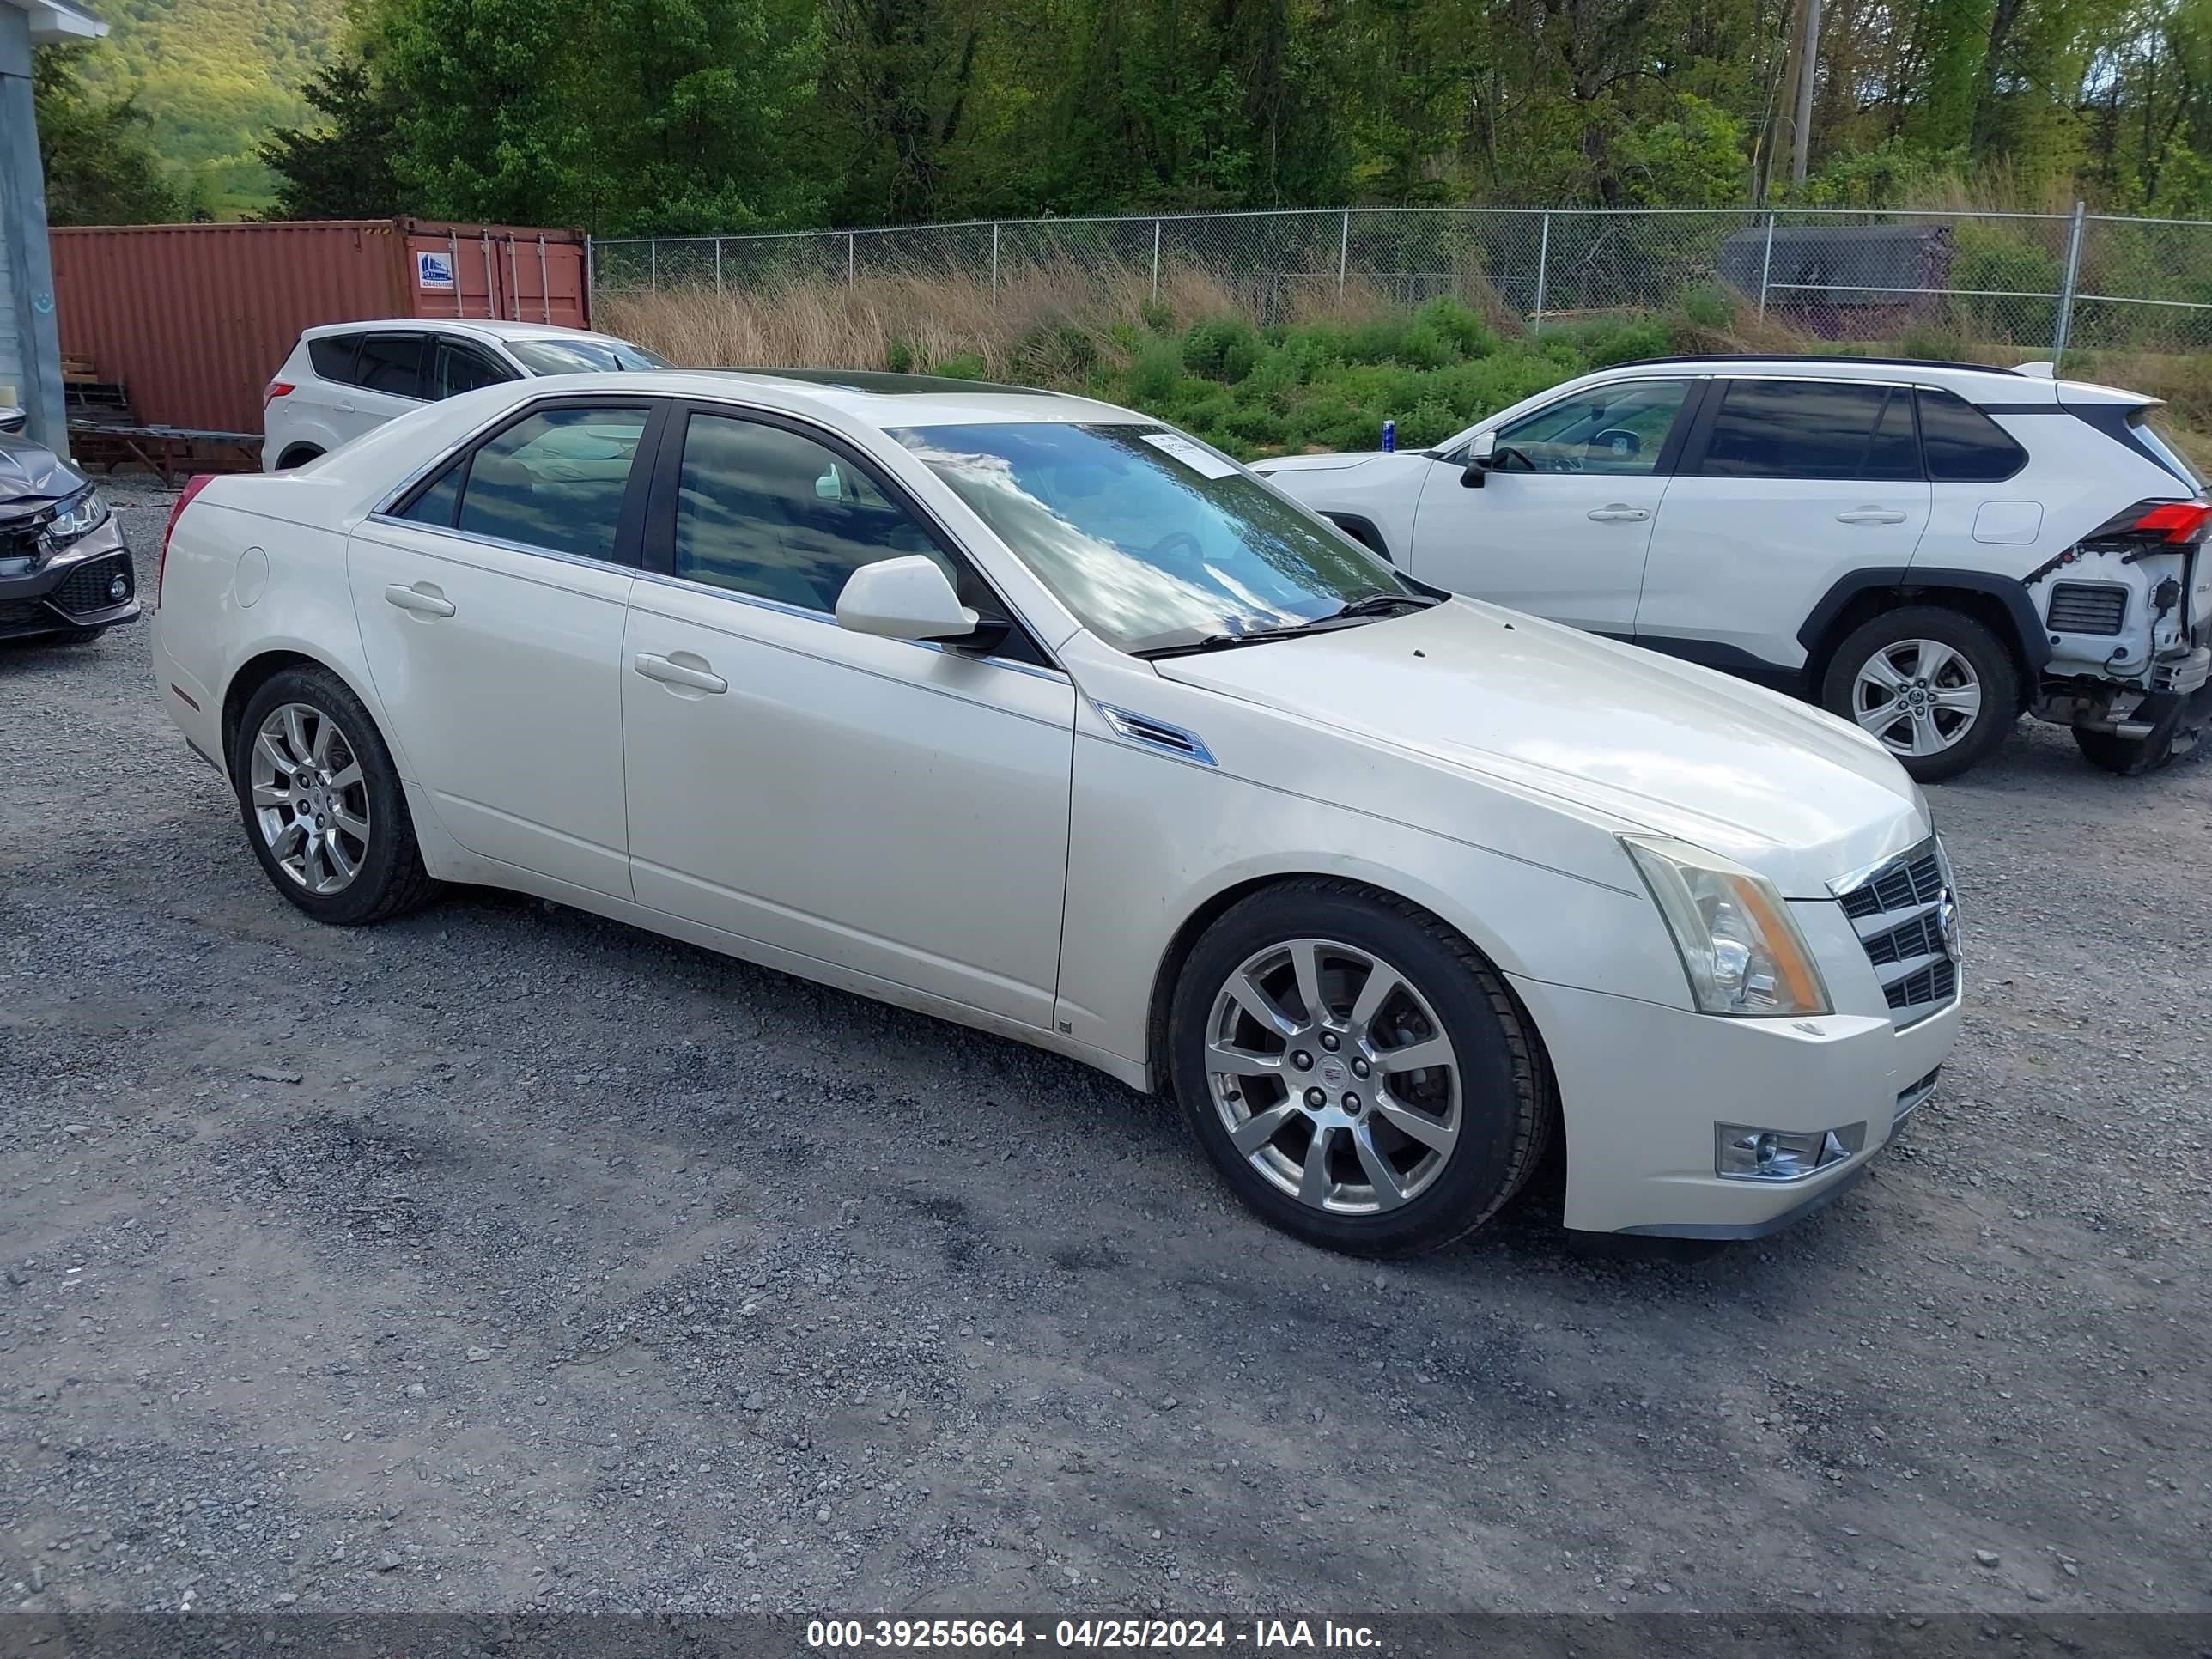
[[1621, 836, 1829, 1018]]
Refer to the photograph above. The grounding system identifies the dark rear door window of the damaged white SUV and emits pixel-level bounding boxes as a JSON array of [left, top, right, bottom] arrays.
[[1698, 380, 1920, 480]]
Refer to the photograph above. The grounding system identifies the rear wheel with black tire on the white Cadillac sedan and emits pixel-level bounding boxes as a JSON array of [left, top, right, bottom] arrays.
[[230, 664, 435, 927]]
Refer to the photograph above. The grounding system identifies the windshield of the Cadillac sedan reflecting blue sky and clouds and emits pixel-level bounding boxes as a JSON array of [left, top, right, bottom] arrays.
[[891, 422, 1425, 650]]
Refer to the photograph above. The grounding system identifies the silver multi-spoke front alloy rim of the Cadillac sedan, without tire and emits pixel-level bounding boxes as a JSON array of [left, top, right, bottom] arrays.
[[1206, 938, 1460, 1214]]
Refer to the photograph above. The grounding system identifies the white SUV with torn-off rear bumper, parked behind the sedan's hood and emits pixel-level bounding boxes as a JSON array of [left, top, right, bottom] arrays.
[[1256, 356, 2212, 781]]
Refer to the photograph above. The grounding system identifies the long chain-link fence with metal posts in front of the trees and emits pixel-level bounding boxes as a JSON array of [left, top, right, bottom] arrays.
[[591, 208, 2212, 367]]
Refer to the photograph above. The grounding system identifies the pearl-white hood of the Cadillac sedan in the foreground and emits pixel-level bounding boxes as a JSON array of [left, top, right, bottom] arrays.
[[1152, 599, 1927, 898]]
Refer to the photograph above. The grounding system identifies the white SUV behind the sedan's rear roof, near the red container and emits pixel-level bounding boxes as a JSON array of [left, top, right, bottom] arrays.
[[261, 316, 671, 473]]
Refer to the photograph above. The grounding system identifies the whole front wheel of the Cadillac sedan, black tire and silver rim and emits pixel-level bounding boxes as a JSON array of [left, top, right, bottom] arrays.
[[1168, 878, 1553, 1256]]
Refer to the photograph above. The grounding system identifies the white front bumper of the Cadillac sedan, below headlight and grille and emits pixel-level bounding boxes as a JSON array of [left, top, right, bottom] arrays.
[[1513, 964, 1960, 1239]]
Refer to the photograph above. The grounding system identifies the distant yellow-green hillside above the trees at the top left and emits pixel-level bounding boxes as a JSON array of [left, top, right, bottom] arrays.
[[84, 0, 345, 219]]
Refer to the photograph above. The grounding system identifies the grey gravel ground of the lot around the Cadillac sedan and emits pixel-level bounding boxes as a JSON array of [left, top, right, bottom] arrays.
[[0, 483, 2212, 1614]]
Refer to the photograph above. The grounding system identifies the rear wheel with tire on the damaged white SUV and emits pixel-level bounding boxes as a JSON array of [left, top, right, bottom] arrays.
[[1820, 604, 2020, 783]]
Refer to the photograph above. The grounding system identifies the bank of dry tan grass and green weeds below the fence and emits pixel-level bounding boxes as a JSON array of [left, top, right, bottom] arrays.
[[595, 268, 2212, 465]]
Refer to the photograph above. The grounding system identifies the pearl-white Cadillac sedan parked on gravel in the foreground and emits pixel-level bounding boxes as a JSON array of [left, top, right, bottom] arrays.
[[153, 372, 1960, 1252]]
